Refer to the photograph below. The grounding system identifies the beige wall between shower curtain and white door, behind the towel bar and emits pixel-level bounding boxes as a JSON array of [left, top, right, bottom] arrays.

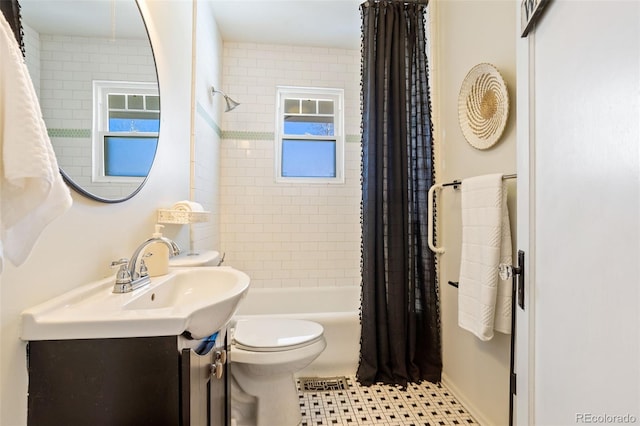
[[431, 0, 516, 425]]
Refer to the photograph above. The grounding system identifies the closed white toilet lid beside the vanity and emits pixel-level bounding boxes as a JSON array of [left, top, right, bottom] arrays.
[[233, 318, 324, 351]]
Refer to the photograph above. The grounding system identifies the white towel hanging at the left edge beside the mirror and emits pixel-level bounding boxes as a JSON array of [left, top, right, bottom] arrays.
[[0, 14, 72, 272]]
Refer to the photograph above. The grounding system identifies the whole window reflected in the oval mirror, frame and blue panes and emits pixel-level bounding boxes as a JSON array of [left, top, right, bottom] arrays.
[[92, 81, 160, 182]]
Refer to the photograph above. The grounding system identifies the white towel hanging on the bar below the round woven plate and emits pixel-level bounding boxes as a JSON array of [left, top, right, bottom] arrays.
[[458, 174, 512, 341]]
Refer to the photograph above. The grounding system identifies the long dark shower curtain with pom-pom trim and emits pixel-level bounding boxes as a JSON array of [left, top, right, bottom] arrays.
[[357, 1, 442, 386]]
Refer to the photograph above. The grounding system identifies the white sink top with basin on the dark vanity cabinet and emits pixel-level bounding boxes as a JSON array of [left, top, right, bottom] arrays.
[[21, 266, 250, 340]]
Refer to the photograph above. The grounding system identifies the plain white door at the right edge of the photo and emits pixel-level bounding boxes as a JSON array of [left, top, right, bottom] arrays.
[[516, 0, 640, 425]]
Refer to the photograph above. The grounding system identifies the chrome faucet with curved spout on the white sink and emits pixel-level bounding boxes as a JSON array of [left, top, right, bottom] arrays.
[[111, 237, 180, 293]]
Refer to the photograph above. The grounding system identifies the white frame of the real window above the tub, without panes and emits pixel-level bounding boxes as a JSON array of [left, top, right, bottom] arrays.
[[274, 86, 345, 184]]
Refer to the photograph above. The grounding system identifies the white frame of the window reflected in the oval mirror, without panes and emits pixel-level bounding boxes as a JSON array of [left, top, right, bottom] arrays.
[[91, 80, 160, 184]]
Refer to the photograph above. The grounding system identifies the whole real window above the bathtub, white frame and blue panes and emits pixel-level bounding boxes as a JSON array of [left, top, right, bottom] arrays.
[[275, 87, 344, 183]]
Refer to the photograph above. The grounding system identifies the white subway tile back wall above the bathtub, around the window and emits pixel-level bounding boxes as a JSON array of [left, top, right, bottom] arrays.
[[220, 42, 361, 287]]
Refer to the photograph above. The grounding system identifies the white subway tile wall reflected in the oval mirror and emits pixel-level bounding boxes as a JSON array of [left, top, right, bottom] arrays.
[[33, 31, 156, 197]]
